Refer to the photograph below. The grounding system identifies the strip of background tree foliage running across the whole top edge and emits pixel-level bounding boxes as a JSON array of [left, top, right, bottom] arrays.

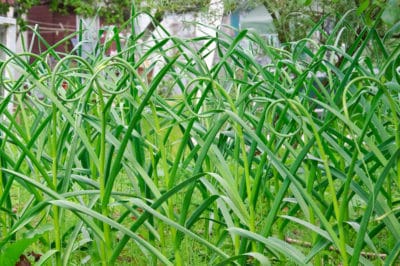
[[0, 0, 400, 44]]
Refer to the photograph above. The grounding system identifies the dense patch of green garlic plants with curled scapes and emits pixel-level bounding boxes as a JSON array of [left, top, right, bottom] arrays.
[[0, 5, 400, 265]]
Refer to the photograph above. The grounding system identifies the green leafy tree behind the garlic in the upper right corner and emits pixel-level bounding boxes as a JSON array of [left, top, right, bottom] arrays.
[[248, 0, 400, 43]]
